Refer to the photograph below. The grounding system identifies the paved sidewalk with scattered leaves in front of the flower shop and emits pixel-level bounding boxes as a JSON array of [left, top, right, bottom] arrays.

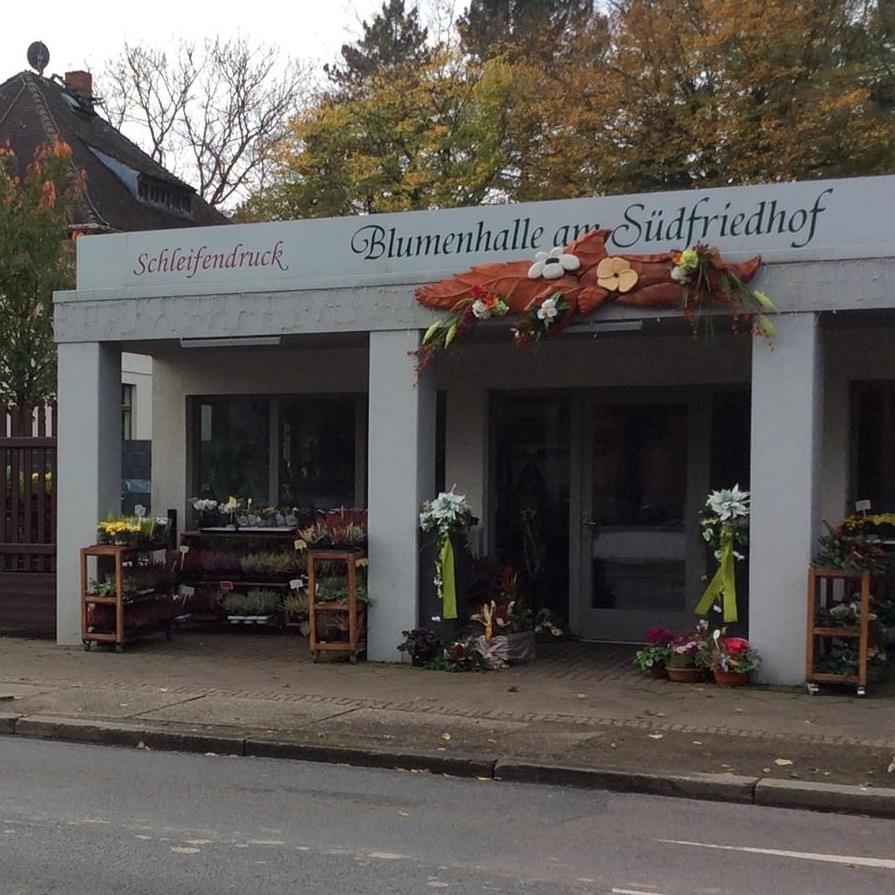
[[0, 633, 895, 787]]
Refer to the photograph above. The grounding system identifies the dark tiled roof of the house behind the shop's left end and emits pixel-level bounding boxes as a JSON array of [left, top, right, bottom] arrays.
[[0, 71, 228, 232]]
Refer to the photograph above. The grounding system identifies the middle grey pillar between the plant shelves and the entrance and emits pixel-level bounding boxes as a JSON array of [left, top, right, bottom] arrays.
[[367, 330, 436, 661]]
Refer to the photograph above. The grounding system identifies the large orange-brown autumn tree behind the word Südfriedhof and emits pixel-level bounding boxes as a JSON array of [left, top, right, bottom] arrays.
[[526, 0, 895, 198]]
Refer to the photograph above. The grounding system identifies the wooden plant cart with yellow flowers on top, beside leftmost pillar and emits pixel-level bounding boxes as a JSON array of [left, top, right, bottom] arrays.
[[81, 543, 173, 653]]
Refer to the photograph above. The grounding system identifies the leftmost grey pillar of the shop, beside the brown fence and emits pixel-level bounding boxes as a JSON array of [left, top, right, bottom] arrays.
[[56, 342, 121, 643]]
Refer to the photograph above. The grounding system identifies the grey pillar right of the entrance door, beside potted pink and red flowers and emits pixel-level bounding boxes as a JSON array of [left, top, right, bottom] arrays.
[[749, 314, 823, 684]]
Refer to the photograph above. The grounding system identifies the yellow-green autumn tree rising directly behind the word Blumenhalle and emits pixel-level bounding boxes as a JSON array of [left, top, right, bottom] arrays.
[[244, 49, 515, 219]]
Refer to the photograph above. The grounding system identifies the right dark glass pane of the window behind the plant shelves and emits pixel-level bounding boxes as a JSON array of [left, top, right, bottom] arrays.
[[279, 397, 363, 508]]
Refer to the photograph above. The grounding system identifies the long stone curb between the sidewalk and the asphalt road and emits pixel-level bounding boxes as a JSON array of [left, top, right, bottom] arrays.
[[0, 713, 895, 818]]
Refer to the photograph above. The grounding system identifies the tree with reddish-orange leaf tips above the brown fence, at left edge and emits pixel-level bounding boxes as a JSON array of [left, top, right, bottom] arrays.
[[0, 142, 83, 429]]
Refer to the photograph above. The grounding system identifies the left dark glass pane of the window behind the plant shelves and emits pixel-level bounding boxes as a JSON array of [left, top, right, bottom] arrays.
[[196, 396, 270, 505]]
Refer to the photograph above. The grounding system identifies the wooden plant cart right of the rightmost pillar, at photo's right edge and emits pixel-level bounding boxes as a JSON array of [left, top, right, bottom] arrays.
[[805, 566, 872, 696]]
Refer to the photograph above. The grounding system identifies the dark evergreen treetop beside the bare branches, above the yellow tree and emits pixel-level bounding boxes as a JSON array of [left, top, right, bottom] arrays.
[[323, 0, 432, 96]]
